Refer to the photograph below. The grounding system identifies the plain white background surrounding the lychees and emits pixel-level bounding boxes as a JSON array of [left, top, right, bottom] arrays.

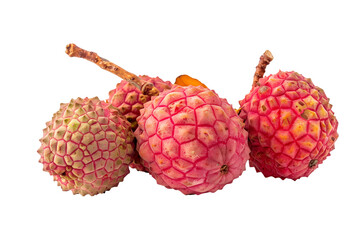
[[0, 0, 360, 239]]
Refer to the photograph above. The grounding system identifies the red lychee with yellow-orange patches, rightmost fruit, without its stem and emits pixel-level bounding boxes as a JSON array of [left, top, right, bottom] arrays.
[[240, 71, 338, 180]]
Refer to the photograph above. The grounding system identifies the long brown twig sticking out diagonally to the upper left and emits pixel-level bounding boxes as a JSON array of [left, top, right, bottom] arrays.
[[65, 43, 159, 96]]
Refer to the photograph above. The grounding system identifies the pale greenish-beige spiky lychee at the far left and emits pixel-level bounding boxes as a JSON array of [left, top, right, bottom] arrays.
[[38, 98, 134, 196]]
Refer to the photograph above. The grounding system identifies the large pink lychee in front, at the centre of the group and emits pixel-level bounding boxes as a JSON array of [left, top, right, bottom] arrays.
[[135, 86, 250, 194]]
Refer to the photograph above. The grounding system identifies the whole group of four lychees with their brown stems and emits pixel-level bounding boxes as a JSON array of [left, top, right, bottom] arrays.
[[38, 44, 338, 195]]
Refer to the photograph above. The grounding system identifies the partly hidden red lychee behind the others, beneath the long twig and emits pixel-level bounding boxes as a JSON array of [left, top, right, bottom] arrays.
[[108, 75, 172, 130]]
